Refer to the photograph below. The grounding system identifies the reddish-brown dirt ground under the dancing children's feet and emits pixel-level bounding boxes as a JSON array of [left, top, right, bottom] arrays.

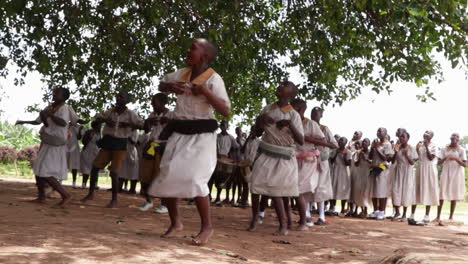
[[0, 180, 468, 264]]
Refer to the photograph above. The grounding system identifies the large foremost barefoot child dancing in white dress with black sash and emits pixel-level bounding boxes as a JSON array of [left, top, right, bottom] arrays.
[[149, 39, 231, 245]]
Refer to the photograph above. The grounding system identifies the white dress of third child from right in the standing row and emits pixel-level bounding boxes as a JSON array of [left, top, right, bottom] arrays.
[[392, 145, 418, 207]]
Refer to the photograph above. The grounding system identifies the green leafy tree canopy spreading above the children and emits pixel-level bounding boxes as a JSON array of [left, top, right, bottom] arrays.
[[0, 0, 468, 121]]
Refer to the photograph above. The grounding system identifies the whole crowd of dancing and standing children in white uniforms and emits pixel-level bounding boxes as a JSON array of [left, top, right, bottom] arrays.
[[13, 39, 467, 245]]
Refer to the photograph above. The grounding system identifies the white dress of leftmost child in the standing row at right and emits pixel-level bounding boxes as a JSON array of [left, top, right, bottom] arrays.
[[332, 149, 351, 200]]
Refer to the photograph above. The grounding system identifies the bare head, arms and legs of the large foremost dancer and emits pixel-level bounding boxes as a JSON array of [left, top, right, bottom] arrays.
[[159, 39, 231, 245]]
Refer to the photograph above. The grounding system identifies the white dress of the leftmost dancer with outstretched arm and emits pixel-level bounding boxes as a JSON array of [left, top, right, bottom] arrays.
[[33, 104, 78, 180]]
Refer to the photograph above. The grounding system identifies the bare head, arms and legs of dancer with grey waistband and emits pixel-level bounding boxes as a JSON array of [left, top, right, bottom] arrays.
[[247, 83, 304, 235]]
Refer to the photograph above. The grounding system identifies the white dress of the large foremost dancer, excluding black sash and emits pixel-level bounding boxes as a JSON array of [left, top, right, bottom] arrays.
[[148, 68, 231, 198]]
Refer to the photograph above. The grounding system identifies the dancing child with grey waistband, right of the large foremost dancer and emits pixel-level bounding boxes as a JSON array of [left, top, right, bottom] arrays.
[[248, 82, 307, 235]]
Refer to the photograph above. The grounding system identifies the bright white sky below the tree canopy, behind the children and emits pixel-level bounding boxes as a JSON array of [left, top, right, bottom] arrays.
[[0, 56, 468, 146]]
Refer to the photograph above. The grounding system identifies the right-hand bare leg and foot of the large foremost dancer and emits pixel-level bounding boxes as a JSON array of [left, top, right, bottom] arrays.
[[192, 196, 213, 245]]
